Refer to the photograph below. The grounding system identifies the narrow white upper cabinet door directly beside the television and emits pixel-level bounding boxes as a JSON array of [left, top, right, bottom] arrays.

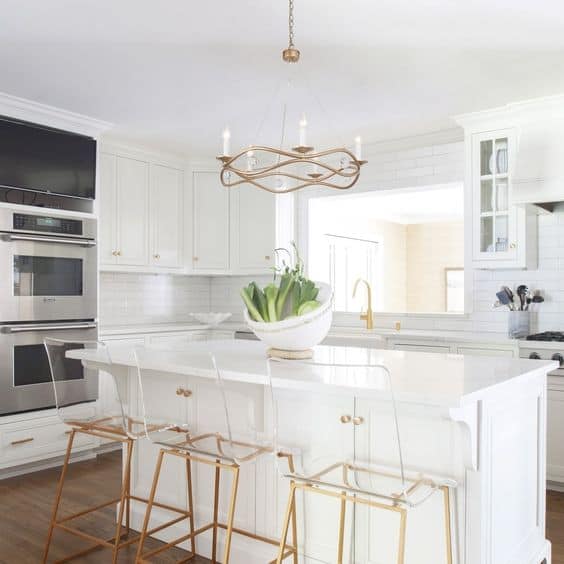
[[98, 153, 117, 264]]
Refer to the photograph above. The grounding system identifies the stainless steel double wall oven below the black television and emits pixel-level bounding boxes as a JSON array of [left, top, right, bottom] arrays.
[[0, 208, 98, 415]]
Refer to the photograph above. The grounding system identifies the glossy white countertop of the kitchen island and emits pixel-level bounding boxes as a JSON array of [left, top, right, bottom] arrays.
[[68, 340, 557, 408]]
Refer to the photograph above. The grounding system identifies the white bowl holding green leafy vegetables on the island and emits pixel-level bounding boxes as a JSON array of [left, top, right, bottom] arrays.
[[243, 282, 333, 351]]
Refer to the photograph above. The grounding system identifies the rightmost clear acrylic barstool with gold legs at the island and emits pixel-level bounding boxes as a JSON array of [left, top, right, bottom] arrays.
[[267, 359, 456, 564]]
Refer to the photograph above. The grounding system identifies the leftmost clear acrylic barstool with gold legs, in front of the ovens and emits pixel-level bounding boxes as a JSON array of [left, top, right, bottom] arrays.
[[43, 339, 189, 564]]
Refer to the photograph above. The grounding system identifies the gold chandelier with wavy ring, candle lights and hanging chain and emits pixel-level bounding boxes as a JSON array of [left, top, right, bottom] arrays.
[[217, 0, 367, 194]]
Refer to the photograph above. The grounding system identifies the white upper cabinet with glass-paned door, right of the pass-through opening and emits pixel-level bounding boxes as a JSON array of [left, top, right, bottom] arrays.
[[459, 115, 537, 269]]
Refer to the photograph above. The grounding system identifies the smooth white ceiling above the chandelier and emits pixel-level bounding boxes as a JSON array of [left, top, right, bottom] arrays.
[[0, 0, 564, 156]]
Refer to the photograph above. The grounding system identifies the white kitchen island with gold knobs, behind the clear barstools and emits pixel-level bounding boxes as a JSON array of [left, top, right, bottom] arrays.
[[68, 341, 556, 564]]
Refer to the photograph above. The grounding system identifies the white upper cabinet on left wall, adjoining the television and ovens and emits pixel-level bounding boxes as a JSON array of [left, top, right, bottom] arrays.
[[98, 152, 183, 270]]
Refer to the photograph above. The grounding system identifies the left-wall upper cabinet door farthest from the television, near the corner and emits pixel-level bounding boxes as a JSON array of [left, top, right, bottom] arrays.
[[149, 165, 183, 268]]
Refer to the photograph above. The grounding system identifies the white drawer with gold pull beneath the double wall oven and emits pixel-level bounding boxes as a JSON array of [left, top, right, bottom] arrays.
[[0, 419, 97, 462]]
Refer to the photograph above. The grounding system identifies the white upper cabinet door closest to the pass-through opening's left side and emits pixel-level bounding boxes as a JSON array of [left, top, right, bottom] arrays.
[[231, 186, 276, 272]]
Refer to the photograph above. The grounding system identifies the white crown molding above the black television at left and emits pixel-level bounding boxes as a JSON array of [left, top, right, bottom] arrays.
[[0, 92, 113, 138]]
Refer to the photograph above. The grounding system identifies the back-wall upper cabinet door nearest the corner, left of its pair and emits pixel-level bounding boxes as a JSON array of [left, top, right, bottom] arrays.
[[193, 172, 229, 272]]
